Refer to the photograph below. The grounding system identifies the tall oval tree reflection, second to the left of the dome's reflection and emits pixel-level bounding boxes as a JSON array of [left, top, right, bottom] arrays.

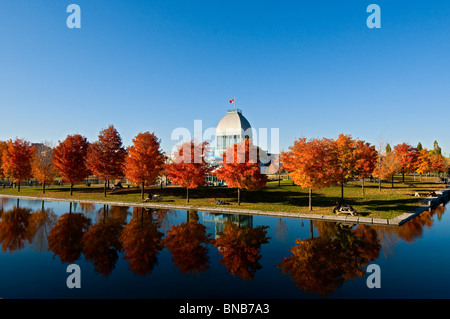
[[119, 207, 164, 275]]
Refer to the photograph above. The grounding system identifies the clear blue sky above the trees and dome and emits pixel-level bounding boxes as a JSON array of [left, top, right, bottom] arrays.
[[0, 0, 450, 155]]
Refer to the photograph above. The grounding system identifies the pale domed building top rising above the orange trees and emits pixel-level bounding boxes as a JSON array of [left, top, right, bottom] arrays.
[[214, 109, 253, 157]]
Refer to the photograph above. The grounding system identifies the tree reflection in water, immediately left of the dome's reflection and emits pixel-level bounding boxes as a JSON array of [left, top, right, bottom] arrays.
[[163, 211, 212, 273]]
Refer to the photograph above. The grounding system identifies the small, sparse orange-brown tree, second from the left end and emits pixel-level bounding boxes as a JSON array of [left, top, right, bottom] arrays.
[[31, 146, 58, 194]]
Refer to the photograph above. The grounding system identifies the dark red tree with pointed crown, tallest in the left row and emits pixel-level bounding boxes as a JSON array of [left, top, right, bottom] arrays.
[[86, 125, 127, 197]]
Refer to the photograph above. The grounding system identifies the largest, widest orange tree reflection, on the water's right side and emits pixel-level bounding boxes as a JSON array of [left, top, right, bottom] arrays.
[[279, 222, 381, 296]]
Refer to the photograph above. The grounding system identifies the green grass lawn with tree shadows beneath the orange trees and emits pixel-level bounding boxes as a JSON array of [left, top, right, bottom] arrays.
[[0, 176, 443, 218]]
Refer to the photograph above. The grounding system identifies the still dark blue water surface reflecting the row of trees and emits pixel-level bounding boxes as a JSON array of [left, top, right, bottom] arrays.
[[0, 198, 450, 299]]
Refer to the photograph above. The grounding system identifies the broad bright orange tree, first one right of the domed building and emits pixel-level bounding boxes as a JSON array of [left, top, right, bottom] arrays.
[[281, 137, 338, 210]]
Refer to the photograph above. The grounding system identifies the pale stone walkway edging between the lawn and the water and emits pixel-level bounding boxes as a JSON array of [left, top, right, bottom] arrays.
[[0, 188, 450, 226]]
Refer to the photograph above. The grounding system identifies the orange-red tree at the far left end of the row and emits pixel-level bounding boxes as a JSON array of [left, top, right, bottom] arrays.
[[2, 138, 34, 192]]
